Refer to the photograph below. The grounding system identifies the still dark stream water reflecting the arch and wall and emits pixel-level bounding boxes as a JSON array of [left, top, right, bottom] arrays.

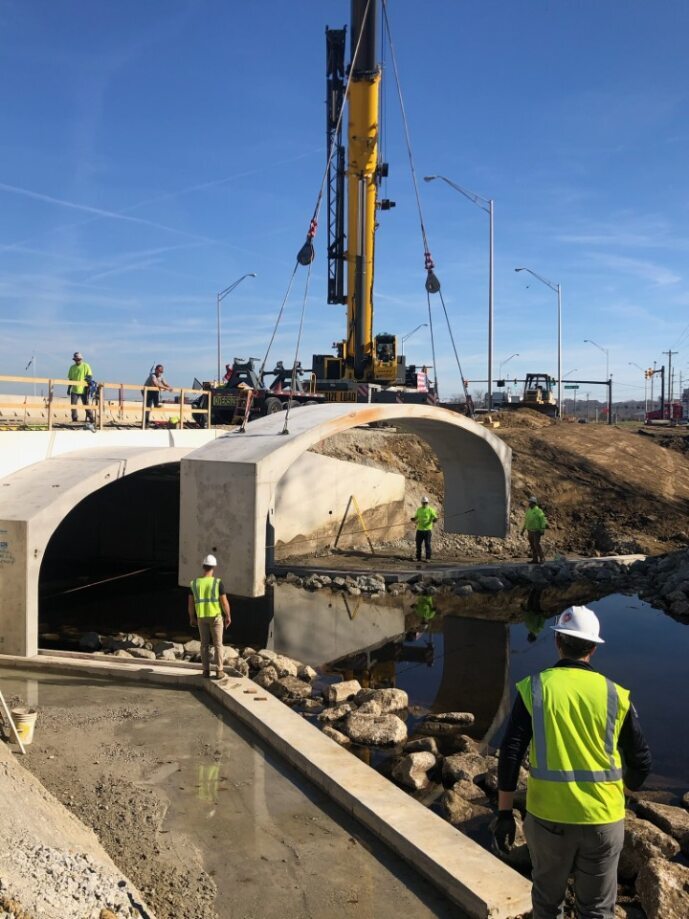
[[41, 577, 689, 792]]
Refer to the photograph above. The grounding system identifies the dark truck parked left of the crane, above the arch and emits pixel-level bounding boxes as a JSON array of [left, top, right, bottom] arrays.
[[195, 357, 324, 426]]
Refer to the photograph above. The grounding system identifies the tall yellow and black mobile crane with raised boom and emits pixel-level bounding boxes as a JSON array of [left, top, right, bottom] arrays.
[[312, 0, 434, 402]]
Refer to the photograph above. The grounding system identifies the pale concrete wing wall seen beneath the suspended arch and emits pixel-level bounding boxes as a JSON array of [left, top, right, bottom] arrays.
[[275, 453, 405, 558]]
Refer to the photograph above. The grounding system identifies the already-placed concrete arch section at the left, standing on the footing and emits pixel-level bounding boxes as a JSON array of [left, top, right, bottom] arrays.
[[0, 445, 199, 657]]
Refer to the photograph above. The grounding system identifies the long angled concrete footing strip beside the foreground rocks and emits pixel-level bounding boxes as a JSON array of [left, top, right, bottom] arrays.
[[0, 654, 531, 919]]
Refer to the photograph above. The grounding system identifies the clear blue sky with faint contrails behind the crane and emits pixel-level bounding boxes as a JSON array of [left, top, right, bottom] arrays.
[[0, 0, 689, 398]]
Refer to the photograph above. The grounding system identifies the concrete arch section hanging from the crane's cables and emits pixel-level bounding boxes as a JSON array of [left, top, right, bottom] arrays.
[[179, 404, 511, 597]]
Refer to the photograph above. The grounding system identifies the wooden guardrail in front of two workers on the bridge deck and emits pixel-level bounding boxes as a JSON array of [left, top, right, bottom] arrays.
[[0, 374, 211, 431]]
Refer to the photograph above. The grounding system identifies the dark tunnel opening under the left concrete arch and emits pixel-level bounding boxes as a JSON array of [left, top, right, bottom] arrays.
[[38, 462, 184, 648]]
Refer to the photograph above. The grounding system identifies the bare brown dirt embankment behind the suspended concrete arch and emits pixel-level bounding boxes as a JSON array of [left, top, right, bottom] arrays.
[[316, 411, 689, 559]]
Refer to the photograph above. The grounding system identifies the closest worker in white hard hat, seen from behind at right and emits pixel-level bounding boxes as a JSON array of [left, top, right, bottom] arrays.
[[493, 606, 651, 919]]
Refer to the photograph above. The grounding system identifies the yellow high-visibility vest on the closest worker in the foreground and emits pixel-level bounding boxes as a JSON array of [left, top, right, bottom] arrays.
[[517, 667, 630, 824]]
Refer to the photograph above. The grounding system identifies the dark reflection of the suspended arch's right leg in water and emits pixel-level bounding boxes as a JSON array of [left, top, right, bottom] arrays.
[[433, 615, 510, 740]]
